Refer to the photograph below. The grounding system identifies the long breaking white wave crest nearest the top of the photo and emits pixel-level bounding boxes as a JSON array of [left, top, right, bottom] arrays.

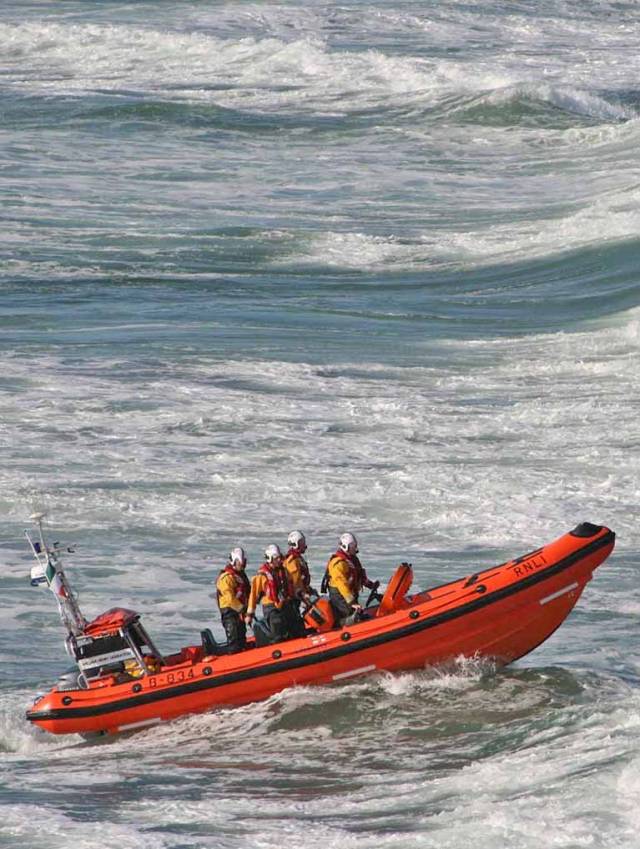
[[6, 17, 636, 125]]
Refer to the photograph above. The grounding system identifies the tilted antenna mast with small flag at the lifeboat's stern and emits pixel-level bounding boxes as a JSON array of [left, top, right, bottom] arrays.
[[24, 511, 87, 637]]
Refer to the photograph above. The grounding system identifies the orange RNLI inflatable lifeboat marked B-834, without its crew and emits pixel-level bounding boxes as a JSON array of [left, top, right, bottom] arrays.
[[27, 523, 615, 734]]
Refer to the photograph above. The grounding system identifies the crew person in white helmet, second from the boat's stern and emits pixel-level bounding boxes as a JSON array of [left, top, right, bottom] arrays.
[[245, 545, 293, 643]]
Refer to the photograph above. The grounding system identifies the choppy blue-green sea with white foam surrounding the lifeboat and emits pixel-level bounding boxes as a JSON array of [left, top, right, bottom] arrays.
[[0, 0, 640, 849]]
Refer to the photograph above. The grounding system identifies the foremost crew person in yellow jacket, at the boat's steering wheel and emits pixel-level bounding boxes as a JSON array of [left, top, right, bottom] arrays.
[[322, 533, 379, 625]]
